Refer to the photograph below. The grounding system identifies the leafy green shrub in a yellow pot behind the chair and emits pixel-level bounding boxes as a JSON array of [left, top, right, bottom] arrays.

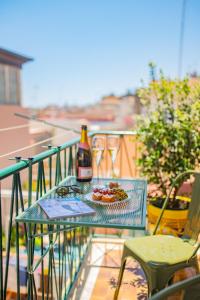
[[138, 67, 200, 234]]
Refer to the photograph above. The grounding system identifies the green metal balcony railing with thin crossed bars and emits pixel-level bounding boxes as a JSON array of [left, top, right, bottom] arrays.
[[0, 131, 138, 300]]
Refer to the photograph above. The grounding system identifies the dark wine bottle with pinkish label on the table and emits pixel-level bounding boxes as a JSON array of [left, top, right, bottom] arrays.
[[76, 125, 92, 182]]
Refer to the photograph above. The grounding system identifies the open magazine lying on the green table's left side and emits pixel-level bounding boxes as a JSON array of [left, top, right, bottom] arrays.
[[38, 197, 96, 219]]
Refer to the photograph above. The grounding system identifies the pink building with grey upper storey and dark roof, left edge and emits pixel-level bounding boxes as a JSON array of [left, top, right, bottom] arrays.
[[0, 48, 32, 168]]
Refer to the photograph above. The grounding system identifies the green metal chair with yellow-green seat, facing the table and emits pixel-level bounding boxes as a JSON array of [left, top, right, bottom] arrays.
[[114, 171, 200, 300]]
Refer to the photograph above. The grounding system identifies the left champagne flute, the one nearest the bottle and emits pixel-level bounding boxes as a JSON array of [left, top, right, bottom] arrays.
[[92, 135, 105, 180]]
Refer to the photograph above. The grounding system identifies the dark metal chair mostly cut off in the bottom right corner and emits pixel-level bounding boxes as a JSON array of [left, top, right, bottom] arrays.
[[149, 275, 200, 300]]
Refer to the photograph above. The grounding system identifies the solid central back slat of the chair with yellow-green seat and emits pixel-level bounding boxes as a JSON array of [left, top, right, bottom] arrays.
[[184, 172, 200, 241]]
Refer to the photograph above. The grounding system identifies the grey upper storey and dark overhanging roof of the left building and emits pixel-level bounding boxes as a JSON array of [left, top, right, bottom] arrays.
[[0, 48, 32, 105]]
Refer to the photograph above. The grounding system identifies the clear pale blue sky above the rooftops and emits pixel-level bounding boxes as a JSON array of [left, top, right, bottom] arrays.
[[0, 0, 200, 107]]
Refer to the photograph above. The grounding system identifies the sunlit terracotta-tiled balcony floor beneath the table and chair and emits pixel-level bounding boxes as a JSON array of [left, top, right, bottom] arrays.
[[70, 238, 198, 300]]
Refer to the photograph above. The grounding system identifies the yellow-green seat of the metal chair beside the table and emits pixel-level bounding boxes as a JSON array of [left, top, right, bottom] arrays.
[[125, 235, 194, 265]]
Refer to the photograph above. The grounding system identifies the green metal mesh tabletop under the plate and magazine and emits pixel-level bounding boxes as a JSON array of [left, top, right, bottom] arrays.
[[16, 177, 147, 230]]
